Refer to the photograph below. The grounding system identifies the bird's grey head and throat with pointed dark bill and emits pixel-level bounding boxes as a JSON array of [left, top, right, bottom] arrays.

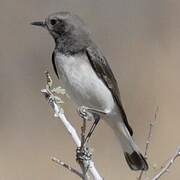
[[31, 12, 91, 53]]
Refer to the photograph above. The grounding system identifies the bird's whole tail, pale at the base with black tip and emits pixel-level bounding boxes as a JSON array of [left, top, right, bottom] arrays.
[[109, 120, 148, 171]]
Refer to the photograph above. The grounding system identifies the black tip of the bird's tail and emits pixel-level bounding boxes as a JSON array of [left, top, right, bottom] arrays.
[[124, 151, 148, 171]]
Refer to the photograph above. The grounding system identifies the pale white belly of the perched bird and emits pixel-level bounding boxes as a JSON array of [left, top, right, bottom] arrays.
[[55, 54, 115, 112]]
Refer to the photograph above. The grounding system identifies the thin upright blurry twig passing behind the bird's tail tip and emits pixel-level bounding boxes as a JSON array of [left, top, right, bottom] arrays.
[[138, 107, 159, 180]]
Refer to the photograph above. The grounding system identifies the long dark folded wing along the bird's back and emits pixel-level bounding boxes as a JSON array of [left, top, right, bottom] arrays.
[[86, 47, 133, 136]]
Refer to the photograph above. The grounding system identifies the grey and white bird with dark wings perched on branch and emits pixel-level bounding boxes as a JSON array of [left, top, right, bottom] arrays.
[[31, 12, 148, 171]]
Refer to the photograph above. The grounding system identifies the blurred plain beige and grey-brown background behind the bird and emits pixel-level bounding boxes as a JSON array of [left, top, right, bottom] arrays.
[[0, 0, 180, 180]]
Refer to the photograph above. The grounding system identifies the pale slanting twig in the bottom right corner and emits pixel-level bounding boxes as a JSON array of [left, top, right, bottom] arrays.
[[152, 146, 180, 180]]
